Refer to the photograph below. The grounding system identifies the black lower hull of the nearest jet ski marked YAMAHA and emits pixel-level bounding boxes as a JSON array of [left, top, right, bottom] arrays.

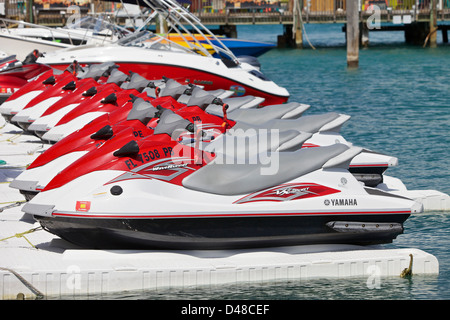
[[35, 212, 410, 249]]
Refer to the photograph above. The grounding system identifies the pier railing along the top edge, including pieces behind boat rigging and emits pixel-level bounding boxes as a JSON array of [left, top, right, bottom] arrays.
[[0, 0, 450, 25]]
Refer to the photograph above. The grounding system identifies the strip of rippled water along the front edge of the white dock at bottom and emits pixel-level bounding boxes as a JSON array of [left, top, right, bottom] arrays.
[[92, 276, 442, 300]]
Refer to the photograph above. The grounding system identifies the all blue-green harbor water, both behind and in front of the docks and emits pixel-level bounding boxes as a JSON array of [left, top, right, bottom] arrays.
[[50, 24, 450, 300]]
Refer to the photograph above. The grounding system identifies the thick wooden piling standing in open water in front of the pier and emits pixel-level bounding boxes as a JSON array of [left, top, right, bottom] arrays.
[[346, 1, 359, 68]]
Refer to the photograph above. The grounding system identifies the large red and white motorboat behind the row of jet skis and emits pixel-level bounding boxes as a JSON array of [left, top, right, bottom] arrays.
[[38, 0, 289, 105]]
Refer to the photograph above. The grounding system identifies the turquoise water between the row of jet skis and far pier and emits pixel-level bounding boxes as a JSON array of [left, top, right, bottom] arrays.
[[253, 25, 450, 198]]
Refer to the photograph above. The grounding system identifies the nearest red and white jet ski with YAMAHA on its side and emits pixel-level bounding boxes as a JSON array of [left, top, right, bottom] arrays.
[[22, 106, 422, 249]]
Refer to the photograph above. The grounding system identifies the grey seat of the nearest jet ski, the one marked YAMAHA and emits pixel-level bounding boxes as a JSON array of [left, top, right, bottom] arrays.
[[182, 144, 349, 196]]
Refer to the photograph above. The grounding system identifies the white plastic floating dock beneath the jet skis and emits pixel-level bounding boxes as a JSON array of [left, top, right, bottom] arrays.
[[0, 120, 442, 299]]
